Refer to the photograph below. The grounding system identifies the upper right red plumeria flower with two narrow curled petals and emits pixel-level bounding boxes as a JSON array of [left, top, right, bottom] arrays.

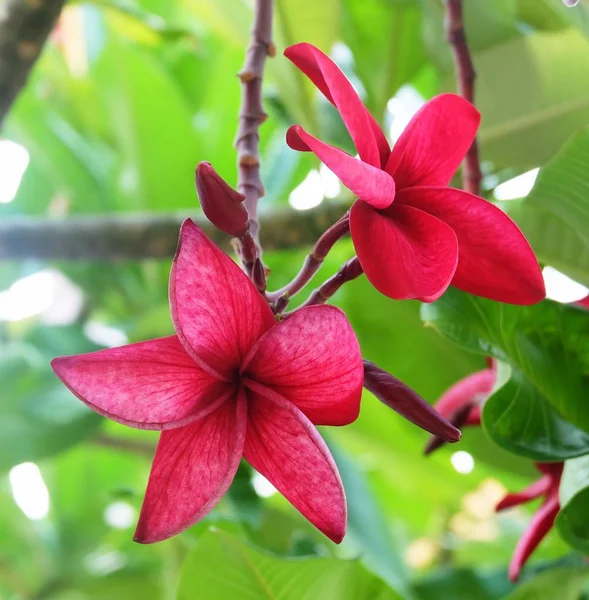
[[285, 44, 545, 304]]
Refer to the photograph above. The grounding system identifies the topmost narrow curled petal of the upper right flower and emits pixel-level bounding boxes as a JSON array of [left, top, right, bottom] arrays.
[[284, 43, 390, 168]]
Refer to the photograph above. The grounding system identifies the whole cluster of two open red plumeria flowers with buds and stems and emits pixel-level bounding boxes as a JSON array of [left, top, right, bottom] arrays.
[[52, 44, 544, 543]]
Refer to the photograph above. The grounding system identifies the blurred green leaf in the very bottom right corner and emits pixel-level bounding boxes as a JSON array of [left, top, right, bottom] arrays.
[[504, 567, 589, 600]]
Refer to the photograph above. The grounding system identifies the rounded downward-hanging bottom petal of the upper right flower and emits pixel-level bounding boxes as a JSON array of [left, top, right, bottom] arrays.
[[350, 201, 458, 302]]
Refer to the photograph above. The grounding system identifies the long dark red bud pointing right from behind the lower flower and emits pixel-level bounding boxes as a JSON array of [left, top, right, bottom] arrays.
[[364, 360, 460, 442]]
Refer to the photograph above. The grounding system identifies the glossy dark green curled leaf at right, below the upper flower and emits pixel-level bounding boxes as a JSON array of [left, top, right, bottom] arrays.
[[422, 288, 589, 460]]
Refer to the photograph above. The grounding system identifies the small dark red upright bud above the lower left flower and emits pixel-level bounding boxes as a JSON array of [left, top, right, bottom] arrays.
[[196, 162, 249, 237]]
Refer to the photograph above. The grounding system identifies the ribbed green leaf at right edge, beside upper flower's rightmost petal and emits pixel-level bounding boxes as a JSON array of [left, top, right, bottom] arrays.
[[505, 127, 589, 285]]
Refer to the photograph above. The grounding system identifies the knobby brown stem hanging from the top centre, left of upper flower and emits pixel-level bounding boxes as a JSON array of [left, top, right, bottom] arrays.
[[235, 0, 276, 252]]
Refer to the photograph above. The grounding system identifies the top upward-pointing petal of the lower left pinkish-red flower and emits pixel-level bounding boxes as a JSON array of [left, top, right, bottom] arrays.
[[170, 219, 275, 380]]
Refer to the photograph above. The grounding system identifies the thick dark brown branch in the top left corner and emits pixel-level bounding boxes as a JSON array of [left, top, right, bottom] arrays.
[[0, 0, 65, 127]]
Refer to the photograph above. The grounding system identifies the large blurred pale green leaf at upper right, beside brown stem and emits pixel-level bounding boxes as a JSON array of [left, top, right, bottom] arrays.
[[474, 29, 589, 168]]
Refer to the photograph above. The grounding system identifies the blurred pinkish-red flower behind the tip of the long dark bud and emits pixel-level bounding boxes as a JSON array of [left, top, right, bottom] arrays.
[[425, 358, 497, 454]]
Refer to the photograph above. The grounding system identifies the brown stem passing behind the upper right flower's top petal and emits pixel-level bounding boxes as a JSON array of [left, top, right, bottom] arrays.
[[444, 0, 483, 195]]
